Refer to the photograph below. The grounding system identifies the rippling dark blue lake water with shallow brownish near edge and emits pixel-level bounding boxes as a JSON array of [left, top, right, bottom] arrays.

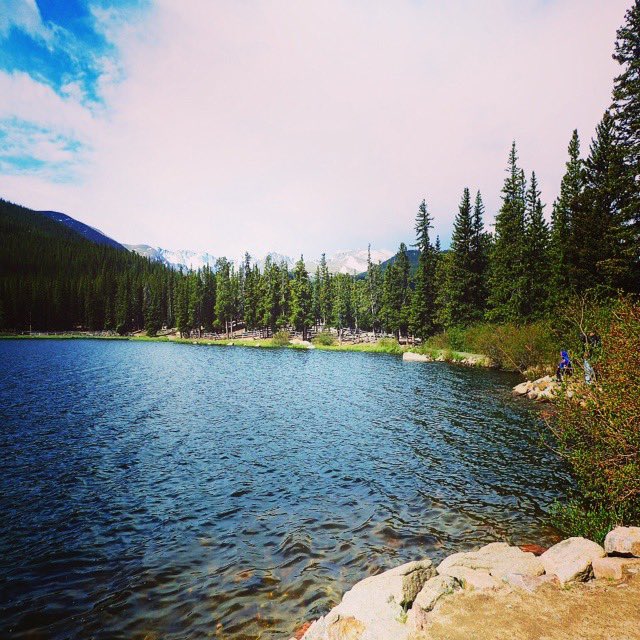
[[0, 340, 567, 640]]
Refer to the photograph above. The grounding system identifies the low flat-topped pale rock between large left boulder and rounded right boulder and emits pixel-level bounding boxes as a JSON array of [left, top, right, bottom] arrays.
[[438, 542, 544, 580]]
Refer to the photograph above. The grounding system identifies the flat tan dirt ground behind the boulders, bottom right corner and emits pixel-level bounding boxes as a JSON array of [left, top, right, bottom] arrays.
[[422, 575, 640, 640]]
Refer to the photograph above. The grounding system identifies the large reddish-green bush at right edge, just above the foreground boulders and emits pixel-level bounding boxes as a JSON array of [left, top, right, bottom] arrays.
[[548, 299, 640, 541]]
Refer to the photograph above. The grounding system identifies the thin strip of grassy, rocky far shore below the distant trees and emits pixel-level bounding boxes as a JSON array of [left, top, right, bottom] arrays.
[[0, 332, 492, 368]]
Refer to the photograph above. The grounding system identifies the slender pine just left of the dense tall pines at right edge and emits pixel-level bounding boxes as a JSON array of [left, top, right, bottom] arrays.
[[551, 129, 584, 303]]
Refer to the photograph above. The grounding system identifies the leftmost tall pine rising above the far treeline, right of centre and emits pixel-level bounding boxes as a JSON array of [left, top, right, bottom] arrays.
[[412, 200, 436, 340]]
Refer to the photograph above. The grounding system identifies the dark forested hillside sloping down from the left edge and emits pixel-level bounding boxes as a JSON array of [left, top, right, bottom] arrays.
[[0, 200, 180, 332]]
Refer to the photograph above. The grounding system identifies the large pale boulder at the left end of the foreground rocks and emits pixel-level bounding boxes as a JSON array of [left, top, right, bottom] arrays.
[[303, 560, 435, 640]]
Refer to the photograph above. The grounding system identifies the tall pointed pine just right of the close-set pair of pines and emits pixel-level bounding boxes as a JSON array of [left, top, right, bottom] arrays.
[[487, 142, 526, 322]]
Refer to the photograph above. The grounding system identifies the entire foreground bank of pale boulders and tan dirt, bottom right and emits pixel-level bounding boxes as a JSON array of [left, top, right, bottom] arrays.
[[290, 527, 640, 640]]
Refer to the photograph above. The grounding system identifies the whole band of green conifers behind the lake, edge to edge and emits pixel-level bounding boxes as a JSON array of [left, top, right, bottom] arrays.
[[0, 0, 640, 339]]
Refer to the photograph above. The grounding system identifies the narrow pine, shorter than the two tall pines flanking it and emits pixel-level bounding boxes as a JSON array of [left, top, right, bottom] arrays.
[[522, 171, 551, 319]]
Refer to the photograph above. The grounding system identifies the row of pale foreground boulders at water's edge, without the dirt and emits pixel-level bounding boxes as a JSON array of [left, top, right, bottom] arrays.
[[292, 527, 640, 640]]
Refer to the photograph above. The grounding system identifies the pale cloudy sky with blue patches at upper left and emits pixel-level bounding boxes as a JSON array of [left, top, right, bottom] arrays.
[[0, 0, 630, 256]]
